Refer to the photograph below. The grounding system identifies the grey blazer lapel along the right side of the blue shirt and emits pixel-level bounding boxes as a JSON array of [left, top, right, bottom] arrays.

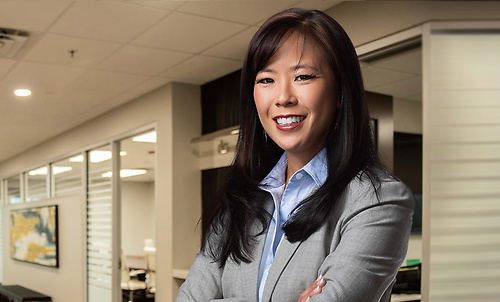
[[262, 237, 302, 302]]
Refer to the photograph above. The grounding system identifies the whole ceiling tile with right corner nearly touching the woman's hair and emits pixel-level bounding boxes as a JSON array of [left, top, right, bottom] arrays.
[[133, 13, 248, 53]]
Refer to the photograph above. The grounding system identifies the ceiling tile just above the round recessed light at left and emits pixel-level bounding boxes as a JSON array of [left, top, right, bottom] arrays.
[[4, 62, 85, 95]]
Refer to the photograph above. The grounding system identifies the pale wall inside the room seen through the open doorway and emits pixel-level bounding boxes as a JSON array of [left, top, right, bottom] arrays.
[[121, 181, 155, 255]]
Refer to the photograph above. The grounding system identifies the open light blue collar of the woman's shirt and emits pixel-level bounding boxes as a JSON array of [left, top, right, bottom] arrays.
[[260, 148, 328, 189]]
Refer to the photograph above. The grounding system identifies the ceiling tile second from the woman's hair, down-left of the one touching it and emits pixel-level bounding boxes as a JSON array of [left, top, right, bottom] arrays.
[[97, 46, 192, 75]]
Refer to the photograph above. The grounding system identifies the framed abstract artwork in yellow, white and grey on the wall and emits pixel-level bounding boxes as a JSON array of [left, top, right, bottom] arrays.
[[10, 205, 59, 267]]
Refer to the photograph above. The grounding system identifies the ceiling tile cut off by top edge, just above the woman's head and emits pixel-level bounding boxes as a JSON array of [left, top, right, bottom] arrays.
[[178, 0, 297, 25]]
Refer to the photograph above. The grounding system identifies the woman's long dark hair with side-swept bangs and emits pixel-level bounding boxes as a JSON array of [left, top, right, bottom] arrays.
[[202, 8, 385, 266]]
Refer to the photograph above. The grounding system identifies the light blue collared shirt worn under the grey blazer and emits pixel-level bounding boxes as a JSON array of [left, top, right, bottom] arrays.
[[258, 149, 328, 302]]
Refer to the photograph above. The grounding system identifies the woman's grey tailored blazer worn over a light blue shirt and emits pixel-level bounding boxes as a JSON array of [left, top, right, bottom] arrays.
[[176, 172, 414, 302]]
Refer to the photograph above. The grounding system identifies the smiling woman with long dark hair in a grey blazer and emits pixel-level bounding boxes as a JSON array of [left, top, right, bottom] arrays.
[[176, 9, 413, 302]]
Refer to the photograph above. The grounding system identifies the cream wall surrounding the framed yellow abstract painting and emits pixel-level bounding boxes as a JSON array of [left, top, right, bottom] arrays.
[[2, 196, 85, 302]]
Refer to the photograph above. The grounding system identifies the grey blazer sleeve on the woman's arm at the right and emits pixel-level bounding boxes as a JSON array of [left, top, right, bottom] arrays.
[[311, 180, 415, 302]]
